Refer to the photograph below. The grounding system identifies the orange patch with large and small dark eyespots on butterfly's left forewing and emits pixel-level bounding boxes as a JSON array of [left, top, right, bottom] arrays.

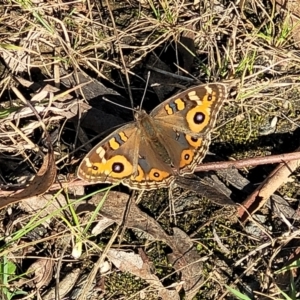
[[90, 155, 132, 179]]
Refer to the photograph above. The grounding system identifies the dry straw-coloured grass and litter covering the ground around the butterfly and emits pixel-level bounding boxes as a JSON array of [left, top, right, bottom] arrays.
[[0, 0, 300, 300]]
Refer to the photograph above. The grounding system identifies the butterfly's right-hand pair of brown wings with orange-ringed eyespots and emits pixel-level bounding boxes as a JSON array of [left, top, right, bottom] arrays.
[[150, 84, 227, 175]]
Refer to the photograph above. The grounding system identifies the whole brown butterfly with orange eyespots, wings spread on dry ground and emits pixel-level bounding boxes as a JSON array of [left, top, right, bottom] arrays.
[[78, 83, 227, 190]]
